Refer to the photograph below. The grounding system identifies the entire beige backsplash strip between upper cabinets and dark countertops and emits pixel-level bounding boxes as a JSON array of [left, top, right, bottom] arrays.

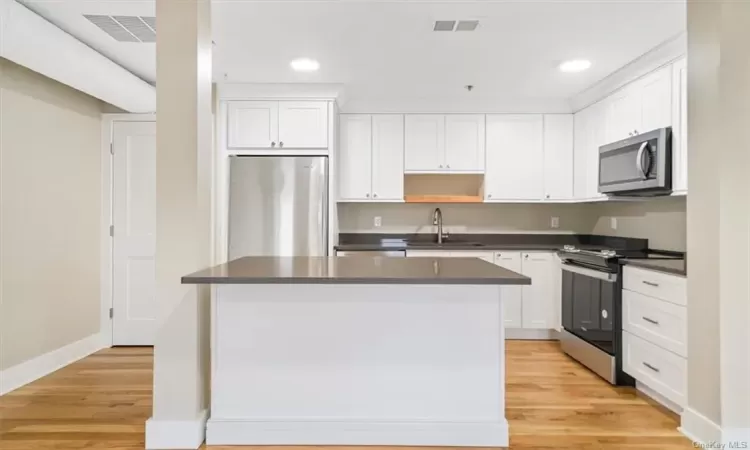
[[339, 197, 686, 251]]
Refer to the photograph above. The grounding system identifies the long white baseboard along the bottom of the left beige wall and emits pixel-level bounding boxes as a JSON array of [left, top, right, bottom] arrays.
[[0, 333, 107, 395]]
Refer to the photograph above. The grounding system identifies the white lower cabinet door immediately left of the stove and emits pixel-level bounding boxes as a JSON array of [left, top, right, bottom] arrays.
[[521, 253, 557, 329]]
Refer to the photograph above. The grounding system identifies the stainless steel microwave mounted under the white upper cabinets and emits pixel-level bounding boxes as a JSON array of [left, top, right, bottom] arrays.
[[599, 127, 672, 196]]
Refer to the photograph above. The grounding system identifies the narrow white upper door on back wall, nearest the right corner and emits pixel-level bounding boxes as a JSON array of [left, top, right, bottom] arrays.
[[544, 114, 573, 200]]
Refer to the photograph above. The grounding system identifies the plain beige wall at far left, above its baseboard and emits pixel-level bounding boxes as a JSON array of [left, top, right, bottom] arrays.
[[0, 59, 102, 370]]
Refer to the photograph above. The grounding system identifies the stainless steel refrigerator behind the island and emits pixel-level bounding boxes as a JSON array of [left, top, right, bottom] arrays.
[[229, 156, 328, 260]]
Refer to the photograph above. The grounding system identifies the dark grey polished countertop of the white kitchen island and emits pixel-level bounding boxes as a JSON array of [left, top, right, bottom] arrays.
[[182, 256, 531, 285]]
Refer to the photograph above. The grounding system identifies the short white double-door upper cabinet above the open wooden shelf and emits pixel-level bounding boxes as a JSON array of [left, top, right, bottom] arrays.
[[404, 114, 485, 173]]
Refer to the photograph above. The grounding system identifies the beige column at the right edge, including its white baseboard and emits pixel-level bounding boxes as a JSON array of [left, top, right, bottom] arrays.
[[682, 0, 750, 442]]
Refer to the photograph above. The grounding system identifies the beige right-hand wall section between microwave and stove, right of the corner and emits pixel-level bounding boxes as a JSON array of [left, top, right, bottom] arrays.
[[589, 197, 687, 251]]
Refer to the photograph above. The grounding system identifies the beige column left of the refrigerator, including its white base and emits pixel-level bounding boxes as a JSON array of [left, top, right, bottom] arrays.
[[146, 0, 213, 449]]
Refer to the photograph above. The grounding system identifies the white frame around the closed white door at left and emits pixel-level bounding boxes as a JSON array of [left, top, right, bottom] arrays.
[[99, 114, 156, 348]]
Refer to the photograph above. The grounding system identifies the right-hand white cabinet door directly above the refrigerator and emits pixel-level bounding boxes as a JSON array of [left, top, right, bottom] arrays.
[[279, 102, 328, 148]]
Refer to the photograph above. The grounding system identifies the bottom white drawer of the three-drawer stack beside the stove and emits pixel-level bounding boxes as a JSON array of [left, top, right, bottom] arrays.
[[622, 331, 687, 407]]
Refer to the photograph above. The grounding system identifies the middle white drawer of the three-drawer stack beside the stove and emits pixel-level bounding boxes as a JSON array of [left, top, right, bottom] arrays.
[[622, 290, 687, 357]]
